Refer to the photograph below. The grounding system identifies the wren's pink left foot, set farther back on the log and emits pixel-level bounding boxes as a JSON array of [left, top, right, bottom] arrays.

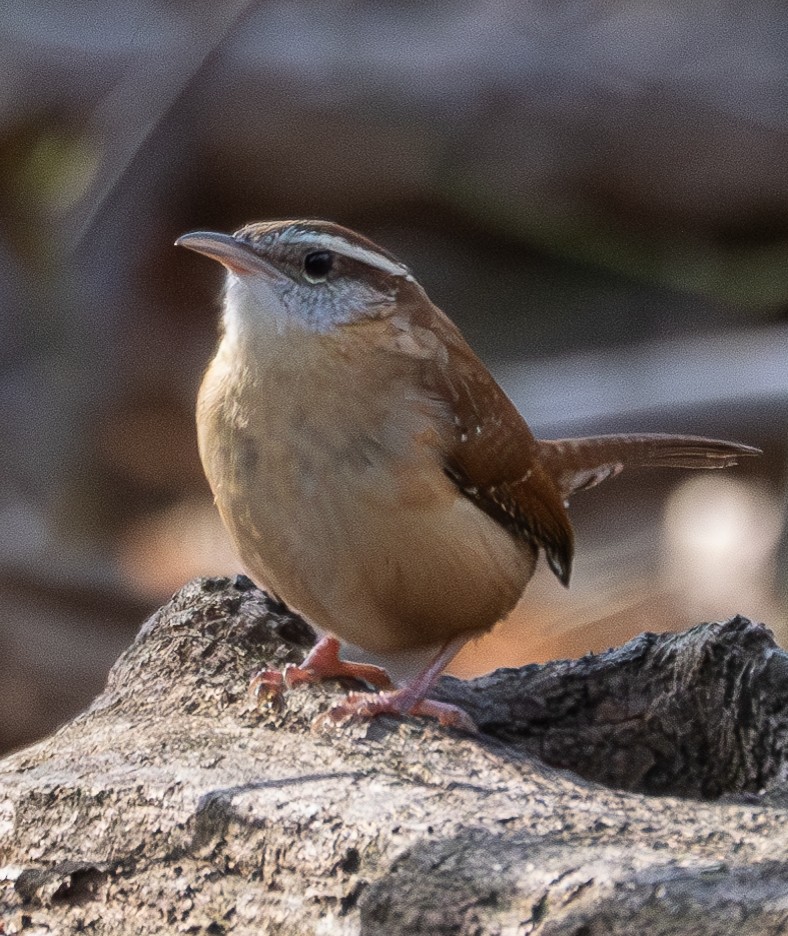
[[249, 634, 394, 704]]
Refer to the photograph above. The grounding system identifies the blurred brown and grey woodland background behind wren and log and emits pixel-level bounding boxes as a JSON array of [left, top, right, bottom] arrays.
[[0, 0, 788, 749]]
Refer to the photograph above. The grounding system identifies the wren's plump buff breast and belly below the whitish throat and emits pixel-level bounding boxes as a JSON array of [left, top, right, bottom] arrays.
[[198, 326, 534, 651]]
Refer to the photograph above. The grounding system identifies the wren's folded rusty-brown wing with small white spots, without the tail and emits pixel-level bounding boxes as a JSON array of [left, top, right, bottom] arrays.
[[406, 300, 574, 585]]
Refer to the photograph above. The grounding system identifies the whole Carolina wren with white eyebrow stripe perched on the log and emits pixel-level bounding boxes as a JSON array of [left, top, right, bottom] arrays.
[[176, 221, 759, 728]]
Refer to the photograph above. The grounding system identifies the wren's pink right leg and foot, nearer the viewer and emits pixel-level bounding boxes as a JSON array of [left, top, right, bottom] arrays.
[[316, 637, 478, 734]]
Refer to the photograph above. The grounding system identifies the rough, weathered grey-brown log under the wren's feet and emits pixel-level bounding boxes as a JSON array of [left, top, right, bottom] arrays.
[[0, 578, 788, 936]]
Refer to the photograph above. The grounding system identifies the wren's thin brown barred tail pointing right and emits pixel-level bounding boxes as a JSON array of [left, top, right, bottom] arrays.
[[538, 433, 761, 497]]
